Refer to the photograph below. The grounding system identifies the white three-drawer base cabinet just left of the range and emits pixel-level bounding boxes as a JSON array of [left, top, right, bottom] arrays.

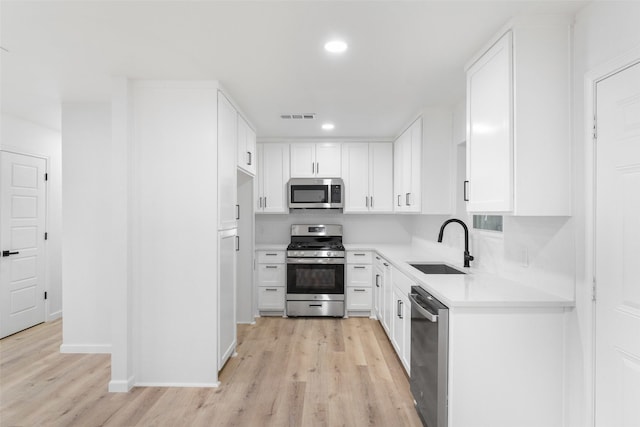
[[256, 251, 287, 315]]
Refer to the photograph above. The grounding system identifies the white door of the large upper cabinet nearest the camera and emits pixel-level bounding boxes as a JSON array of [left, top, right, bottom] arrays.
[[467, 32, 513, 212]]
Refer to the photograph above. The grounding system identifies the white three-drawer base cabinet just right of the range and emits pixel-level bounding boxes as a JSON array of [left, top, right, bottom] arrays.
[[345, 251, 373, 316]]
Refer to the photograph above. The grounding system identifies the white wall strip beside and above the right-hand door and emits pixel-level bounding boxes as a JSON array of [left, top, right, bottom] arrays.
[[567, 1, 640, 427]]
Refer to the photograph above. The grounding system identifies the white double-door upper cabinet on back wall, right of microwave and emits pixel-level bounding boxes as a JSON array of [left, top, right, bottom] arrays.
[[342, 142, 393, 213]]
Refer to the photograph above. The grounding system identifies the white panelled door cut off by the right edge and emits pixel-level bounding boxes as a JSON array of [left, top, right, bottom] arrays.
[[595, 60, 640, 427]]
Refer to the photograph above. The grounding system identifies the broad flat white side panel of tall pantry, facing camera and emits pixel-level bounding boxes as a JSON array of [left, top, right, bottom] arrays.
[[131, 81, 218, 387]]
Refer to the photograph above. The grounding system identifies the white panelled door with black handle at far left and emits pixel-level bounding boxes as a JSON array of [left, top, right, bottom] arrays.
[[0, 151, 46, 338]]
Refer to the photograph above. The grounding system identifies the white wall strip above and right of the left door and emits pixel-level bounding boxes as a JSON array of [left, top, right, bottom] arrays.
[[0, 113, 62, 321]]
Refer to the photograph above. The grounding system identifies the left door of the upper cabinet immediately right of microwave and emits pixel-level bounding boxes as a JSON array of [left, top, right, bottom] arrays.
[[342, 143, 370, 213]]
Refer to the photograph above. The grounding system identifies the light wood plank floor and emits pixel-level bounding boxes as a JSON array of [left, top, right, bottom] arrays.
[[0, 317, 421, 427]]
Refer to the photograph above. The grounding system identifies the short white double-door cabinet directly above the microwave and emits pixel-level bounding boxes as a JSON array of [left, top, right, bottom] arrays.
[[290, 142, 341, 178]]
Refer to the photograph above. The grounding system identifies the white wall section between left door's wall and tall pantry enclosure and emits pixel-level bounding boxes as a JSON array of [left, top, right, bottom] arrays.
[[61, 103, 112, 353]]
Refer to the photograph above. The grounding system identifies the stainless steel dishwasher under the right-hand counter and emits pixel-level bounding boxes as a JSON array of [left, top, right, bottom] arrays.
[[409, 286, 449, 427]]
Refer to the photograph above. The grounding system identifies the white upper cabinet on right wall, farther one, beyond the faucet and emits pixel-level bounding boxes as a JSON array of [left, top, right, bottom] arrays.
[[393, 108, 455, 215]]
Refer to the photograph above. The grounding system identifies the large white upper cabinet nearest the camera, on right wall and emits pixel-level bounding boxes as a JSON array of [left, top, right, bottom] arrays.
[[465, 16, 572, 216]]
